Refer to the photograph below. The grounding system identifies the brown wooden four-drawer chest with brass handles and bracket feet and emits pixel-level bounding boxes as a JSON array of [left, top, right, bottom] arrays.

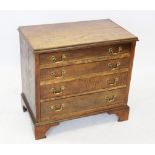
[[19, 19, 138, 139]]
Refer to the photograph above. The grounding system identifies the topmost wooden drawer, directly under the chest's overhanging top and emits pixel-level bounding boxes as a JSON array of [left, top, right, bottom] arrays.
[[40, 43, 131, 68]]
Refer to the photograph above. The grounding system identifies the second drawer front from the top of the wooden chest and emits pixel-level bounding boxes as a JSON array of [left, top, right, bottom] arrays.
[[40, 58, 130, 81]]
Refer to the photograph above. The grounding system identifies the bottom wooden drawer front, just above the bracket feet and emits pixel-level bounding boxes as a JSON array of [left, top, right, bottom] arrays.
[[41, 88, 127, 121]]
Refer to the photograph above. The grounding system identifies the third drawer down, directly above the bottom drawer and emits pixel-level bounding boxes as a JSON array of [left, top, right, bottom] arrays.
[[40, 72, 128, 100]]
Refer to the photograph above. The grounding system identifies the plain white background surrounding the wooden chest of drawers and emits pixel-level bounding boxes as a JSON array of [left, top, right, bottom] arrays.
[[0, 11, 155, 143]]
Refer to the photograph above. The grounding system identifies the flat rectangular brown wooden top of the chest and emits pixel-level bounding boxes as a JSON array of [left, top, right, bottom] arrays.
[[19, 19, 137, 52]]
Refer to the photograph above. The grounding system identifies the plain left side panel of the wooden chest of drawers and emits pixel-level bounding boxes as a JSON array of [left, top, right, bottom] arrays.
[[20, 35, 36, 117]]
